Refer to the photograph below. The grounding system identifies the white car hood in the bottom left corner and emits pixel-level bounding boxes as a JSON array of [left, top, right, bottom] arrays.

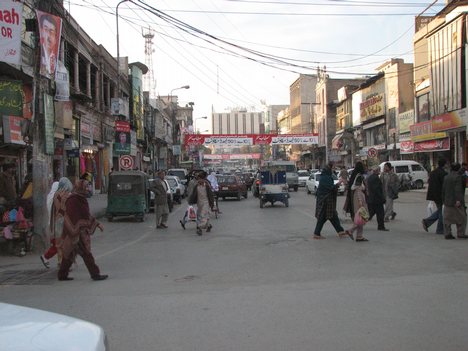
[[0, 303, 106, 351]]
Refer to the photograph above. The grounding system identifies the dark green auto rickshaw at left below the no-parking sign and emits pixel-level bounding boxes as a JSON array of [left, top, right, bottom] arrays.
[[106, 171, 149, 222]]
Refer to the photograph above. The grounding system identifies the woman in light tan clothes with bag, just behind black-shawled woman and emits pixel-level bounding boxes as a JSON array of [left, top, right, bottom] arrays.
[[346, 162, 369, 242]]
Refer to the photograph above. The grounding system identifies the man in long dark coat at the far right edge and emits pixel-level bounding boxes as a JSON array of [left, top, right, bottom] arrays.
[[442, 163, 468, 239]]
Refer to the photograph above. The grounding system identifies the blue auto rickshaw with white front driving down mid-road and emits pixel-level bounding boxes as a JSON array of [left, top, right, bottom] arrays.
[[259, 167, 289, 208]]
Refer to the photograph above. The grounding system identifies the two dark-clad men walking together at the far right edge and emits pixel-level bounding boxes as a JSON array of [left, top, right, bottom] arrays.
[[422, 159, 468, 240]]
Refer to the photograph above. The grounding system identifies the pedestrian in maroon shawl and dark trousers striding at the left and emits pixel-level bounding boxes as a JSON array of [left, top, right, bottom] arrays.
[[58, 179, 108, 280]]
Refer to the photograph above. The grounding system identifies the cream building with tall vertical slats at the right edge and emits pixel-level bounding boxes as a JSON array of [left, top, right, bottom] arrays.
[[412, 1, 468, 169]]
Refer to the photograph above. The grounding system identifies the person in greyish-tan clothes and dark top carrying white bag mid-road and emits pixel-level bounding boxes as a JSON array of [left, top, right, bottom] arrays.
[[189, 172, 214, 235]]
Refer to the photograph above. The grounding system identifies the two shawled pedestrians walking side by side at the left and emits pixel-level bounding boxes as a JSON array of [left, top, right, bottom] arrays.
[[40, 177, 108, 281]]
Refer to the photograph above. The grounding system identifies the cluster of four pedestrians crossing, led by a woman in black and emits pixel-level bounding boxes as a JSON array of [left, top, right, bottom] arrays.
[[314, 161, 399, 242]]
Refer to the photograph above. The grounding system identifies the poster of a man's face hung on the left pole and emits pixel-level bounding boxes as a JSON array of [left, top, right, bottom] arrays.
[[36, 11, 62, 78]]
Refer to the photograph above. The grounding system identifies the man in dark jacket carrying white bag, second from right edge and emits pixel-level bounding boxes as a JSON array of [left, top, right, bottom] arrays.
[[422, 158, 447, 234]]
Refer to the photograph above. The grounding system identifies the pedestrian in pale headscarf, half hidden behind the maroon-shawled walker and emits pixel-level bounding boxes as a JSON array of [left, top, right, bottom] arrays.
[[40, 177, 73, 268]]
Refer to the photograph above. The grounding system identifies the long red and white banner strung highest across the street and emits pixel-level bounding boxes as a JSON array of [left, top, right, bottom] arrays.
[[184, 134, 318, 147]]
